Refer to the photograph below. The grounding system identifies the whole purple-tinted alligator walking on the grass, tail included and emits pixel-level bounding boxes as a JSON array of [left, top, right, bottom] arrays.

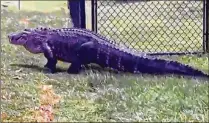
[[8, 27, 209, 78]]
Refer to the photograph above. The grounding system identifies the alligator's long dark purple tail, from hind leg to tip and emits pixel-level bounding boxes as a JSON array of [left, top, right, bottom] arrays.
[[93, 43, 209, 78]]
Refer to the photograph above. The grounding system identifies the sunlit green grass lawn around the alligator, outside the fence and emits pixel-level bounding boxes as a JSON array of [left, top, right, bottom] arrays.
[[1, 1, 209, 122]]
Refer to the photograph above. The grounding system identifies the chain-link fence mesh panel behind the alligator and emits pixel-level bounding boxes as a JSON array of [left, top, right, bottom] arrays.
[[92, 0, 205, 53]]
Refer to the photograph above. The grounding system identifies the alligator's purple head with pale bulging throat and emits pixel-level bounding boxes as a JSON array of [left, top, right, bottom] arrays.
[[8, 28, 51, 54]]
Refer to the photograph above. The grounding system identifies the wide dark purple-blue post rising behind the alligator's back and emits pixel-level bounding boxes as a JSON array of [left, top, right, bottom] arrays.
[[68, 0, 86, 28]]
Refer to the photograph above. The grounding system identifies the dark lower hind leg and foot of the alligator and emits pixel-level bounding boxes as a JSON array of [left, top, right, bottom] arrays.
[[67, 62, 81, 74]]
